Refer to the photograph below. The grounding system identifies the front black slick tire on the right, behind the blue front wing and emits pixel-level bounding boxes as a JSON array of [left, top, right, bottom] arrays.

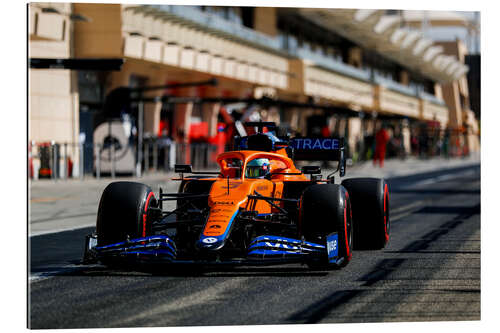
[[299, 184, 353, 268]]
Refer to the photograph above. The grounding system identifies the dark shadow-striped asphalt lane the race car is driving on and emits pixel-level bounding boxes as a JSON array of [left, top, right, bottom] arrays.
[[28, 166, 481, 328]]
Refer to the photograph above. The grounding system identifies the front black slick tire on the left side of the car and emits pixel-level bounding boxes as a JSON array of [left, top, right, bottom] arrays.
[[96, 182, 158, 246]]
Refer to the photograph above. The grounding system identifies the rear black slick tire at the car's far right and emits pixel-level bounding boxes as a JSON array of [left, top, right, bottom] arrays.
[[342, 178, 391, 250]]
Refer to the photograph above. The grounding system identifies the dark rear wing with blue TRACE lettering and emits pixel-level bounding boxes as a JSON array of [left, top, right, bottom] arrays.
[[289, 137, 345, 177]]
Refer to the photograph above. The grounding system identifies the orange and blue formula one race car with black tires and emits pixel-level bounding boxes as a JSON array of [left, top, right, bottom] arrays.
[[84, 122, 390, 269]]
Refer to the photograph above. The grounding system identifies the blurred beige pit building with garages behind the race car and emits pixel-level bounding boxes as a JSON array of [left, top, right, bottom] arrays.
[[28, 3, 480, 177]]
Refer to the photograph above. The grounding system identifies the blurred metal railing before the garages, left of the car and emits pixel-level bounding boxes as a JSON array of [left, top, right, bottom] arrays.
[[28, 138, 224, 181]]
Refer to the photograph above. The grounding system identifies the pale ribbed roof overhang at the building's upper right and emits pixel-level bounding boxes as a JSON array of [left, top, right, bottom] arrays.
[[298, 8, 468, 82]]
